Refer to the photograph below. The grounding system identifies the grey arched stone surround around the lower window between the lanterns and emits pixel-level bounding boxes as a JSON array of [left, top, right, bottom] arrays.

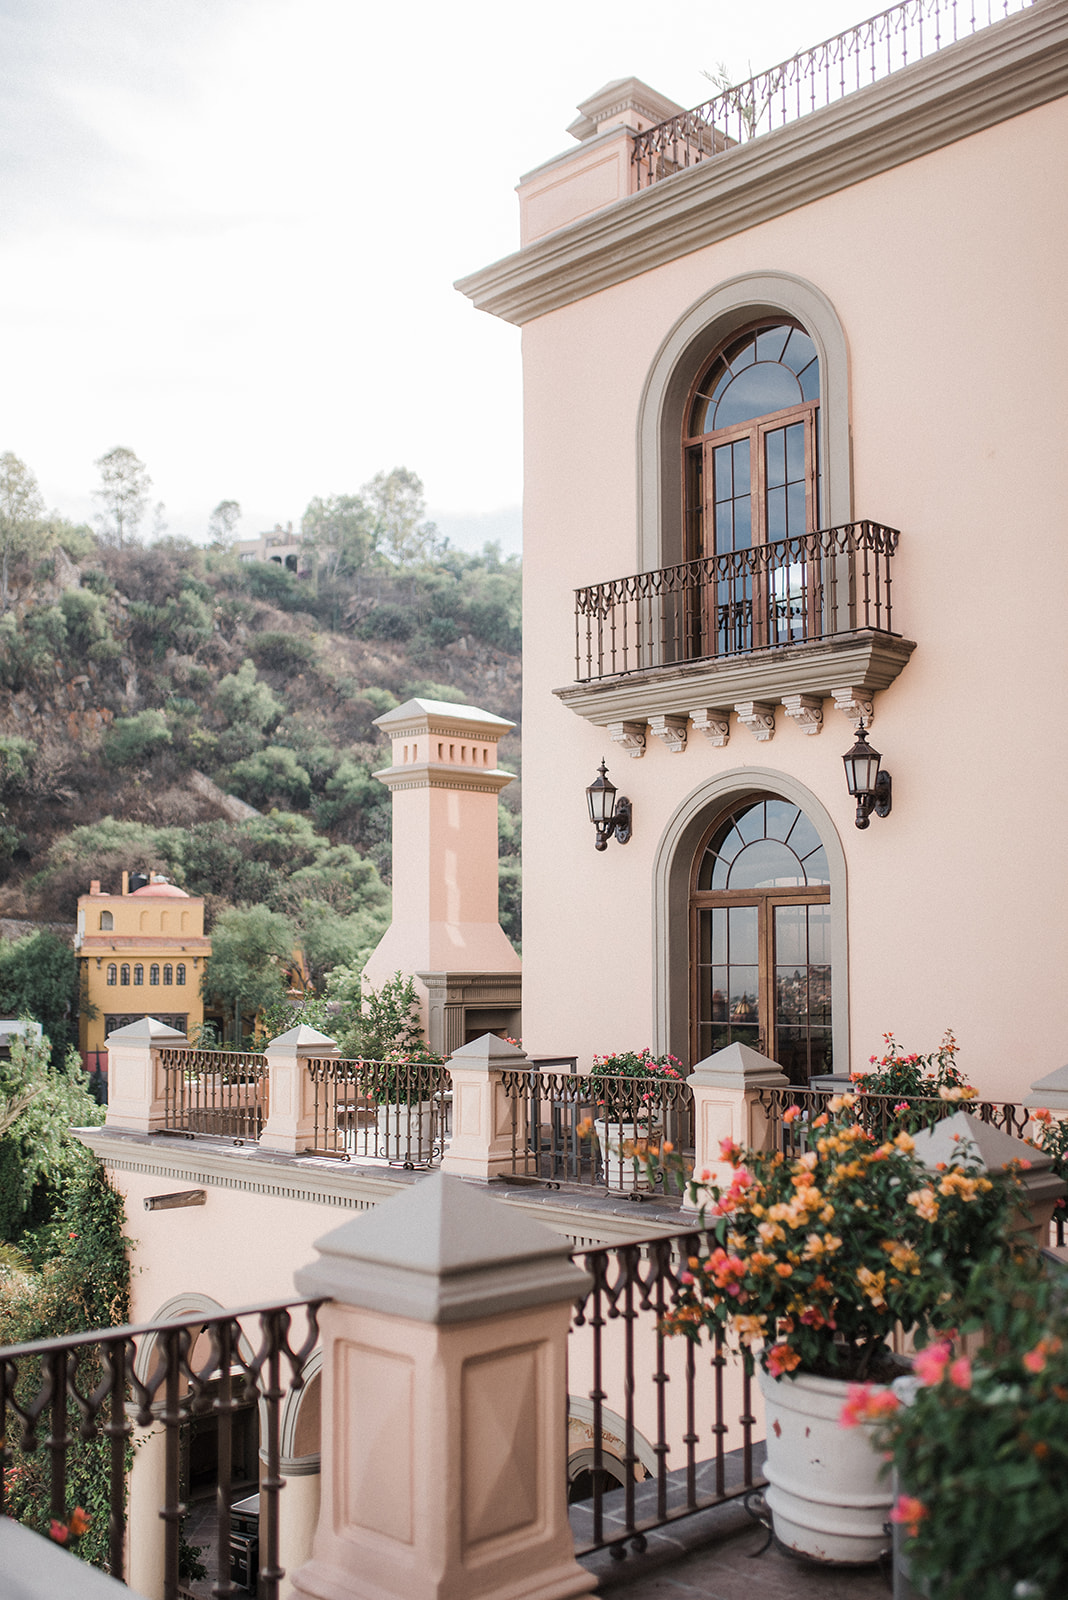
[[652, 766, 849, 1072]]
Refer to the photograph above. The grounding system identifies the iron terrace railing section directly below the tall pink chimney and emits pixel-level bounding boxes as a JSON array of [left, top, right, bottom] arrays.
[[305, 1056, 452, 1168]]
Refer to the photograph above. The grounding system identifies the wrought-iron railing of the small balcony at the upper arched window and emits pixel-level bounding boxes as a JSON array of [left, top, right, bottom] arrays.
[[576, 522, 900, 683]]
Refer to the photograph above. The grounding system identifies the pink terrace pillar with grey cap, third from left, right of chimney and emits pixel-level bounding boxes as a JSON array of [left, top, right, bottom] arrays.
[[441, 1034, 528, 1179]]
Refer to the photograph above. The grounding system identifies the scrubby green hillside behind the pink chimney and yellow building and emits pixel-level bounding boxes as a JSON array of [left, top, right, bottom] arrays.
[[0, 533, 520, 965]]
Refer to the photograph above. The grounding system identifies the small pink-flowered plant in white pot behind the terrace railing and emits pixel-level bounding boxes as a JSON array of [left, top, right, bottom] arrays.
[[590, 1045, 684, 1192]]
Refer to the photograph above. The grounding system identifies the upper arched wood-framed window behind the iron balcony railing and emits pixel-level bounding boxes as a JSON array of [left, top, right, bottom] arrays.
[[683, 320, 820, 654]]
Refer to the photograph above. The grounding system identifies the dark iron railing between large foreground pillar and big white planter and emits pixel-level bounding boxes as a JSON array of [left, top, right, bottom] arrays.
[[569, 1229, 766, 1555]]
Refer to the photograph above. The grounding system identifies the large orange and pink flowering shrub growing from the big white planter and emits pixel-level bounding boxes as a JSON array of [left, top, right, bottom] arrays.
[[664, 1094, 1014, 1378]]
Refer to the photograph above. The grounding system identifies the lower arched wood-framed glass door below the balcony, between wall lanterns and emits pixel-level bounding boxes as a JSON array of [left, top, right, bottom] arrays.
[[691, 795, 831, 1085]]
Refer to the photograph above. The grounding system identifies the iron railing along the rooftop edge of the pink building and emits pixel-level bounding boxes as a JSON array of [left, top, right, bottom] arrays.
[[632, 0, 1033, 189]]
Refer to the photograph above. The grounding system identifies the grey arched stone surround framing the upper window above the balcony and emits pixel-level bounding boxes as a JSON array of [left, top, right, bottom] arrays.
[[636, 272, 852, 573]]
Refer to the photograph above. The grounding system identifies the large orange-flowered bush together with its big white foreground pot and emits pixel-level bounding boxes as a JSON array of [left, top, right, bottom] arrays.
[[665, 1094, 1010, 1562]]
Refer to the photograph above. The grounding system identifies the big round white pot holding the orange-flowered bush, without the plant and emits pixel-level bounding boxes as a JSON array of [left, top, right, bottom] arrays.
[[758, 1371, 894, 1565]]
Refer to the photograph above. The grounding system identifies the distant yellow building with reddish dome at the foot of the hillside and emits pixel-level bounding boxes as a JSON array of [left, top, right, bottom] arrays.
[[75, 872, 211, 1053]]
